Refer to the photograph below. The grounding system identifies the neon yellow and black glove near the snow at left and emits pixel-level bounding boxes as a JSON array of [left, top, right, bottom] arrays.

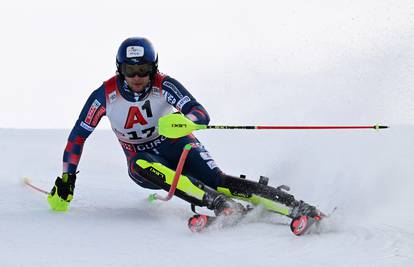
[[47, 172, 76, 211]]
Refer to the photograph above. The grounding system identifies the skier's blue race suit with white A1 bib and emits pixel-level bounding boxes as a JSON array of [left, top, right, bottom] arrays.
[[63, 73, 221, 189]]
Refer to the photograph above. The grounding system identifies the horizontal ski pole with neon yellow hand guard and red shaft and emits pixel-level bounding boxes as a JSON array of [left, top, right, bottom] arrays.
[[158, 113, 388, 138]]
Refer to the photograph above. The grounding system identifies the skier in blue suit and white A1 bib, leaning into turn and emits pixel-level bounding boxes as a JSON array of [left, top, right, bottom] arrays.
[[48, 37, 315, 233]]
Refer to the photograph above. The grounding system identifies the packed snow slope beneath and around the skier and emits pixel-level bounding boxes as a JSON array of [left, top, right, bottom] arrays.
[[0, 125, 414, 267]]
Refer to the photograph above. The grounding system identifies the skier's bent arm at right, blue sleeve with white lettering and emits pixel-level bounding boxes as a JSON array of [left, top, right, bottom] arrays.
[[162, 77, 210, 124]]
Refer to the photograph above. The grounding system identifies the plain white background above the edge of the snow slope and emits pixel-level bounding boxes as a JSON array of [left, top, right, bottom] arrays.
[[0, 0, 414, 128]]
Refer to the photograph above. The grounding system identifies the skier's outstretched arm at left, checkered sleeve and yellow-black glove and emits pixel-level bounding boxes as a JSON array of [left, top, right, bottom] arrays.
[[48, 87, 106, 211]]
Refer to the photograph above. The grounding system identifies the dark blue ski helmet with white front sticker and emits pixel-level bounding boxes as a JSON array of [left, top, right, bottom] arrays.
[[116, 37, 158, 77]]
